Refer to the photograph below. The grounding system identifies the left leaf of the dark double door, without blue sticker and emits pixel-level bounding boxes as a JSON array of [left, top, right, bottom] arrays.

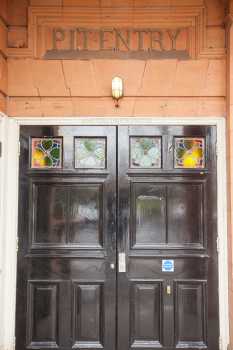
[[16, 126, 116, 350]]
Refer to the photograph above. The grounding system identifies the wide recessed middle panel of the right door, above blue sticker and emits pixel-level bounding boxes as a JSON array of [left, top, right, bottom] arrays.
[[130, 177, 205, 249]]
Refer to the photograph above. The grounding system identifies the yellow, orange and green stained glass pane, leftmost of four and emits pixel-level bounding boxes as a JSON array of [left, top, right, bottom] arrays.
[[31, 137, 62, 169]]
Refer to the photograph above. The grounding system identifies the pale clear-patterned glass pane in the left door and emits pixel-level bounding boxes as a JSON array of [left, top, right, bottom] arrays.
[[75, 137, 106, 169]]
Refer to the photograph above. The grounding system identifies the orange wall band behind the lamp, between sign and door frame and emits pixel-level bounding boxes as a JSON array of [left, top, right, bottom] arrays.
[[8, 59, 225, 116]]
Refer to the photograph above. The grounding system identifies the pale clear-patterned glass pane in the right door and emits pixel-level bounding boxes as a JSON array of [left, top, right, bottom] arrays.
[[130, 137, 161, 168]]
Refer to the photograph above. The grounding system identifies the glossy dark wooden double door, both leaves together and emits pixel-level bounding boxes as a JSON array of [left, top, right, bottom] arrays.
[[16, 126, 219, 350]]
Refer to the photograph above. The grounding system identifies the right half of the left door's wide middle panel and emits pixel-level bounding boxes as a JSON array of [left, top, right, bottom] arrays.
[[69, 185, 102, 245]]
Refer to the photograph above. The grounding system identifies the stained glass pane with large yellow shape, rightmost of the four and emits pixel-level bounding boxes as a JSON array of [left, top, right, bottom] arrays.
[[175, 137, 205, 169]]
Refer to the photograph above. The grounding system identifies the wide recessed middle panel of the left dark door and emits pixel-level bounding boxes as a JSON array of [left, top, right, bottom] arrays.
[[30, 178, 104, 248]]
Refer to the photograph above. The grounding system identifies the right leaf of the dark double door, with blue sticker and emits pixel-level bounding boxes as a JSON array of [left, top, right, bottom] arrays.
[[118, 126, 219, 350]]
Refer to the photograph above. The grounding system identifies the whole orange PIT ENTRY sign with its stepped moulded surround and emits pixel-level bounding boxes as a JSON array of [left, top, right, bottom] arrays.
[[17, 5, 222, 59]]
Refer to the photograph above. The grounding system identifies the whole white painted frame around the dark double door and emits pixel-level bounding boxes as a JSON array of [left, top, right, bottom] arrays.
[[0, 113, 229, 350]]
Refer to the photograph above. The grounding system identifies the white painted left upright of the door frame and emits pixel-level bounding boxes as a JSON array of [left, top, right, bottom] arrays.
[[0, 117, 19, 350]]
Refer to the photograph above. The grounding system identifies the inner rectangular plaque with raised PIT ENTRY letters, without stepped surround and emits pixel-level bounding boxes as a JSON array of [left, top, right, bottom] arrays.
[[43, 27, 190, 59]]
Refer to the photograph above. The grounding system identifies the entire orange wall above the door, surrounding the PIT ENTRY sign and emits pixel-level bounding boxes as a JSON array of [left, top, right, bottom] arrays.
[[1, 0, 226, 116]]
